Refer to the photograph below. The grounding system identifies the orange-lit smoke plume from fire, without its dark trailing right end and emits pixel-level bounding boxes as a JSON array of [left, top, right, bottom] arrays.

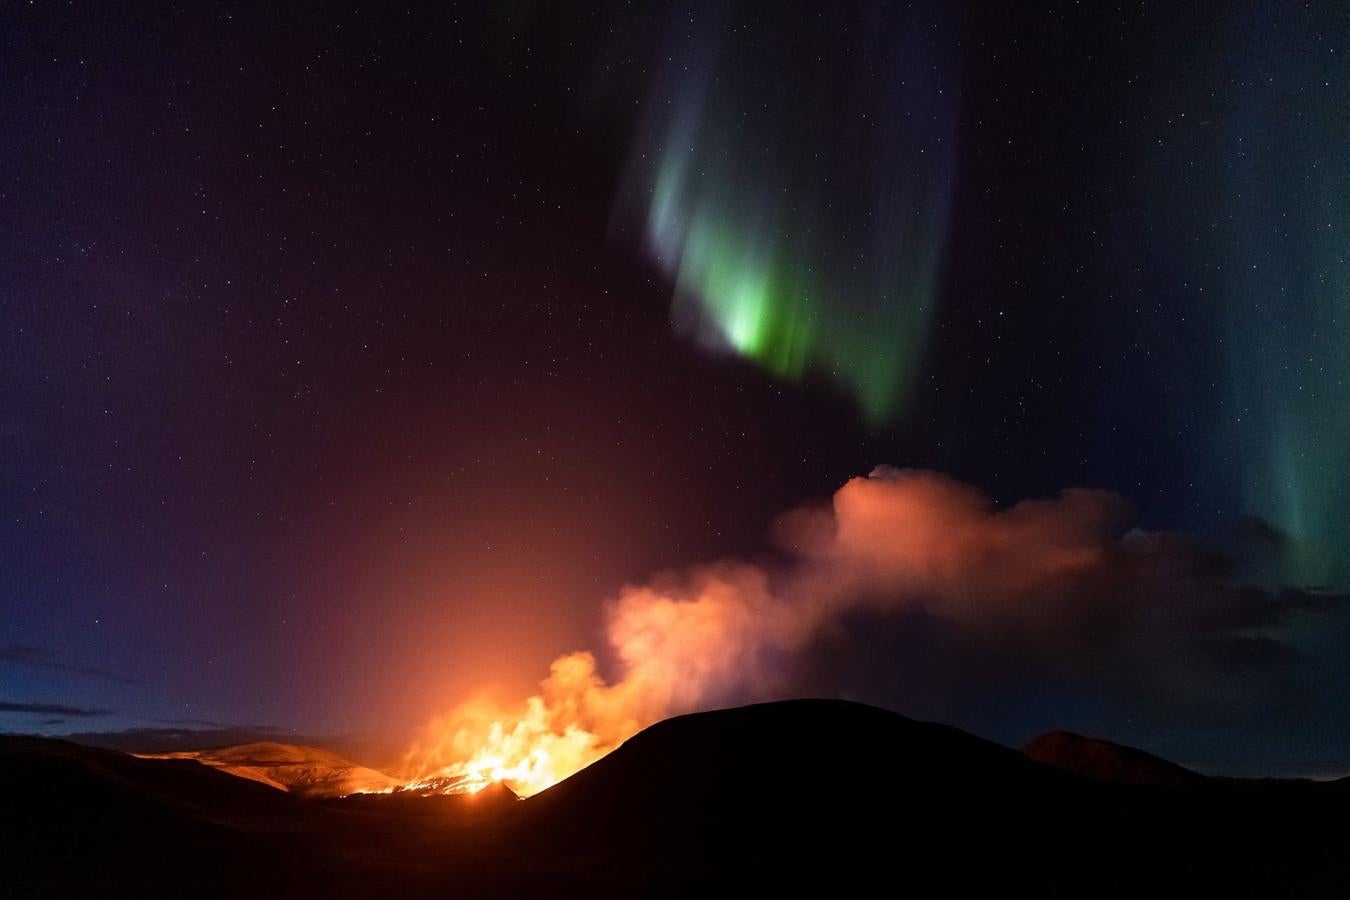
[[408, 470, 1144, 796]]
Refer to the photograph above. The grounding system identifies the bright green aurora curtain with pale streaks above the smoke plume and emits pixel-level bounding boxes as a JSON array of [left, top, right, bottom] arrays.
[[616, 4, 960, 425]]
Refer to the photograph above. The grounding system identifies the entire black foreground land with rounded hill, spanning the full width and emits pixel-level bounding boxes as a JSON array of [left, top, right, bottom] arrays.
[[0, 700, 1350, 899]]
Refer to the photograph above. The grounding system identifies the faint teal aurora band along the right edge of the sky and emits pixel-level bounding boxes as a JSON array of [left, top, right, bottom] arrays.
[[1215, 9, 1350, 584]]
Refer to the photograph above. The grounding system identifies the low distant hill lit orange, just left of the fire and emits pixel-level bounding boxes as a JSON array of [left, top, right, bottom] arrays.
[[138, 741, 400, 797]]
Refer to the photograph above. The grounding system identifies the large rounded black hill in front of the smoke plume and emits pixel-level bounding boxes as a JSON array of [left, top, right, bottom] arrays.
[[486, 700, 1063, 896]]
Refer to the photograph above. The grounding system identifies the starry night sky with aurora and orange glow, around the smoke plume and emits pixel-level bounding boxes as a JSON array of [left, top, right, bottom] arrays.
[[0, 0, 1350, 773]]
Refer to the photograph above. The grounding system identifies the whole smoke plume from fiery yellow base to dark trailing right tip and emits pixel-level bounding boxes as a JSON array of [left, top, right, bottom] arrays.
[[409, 468, 1334, 793]]
